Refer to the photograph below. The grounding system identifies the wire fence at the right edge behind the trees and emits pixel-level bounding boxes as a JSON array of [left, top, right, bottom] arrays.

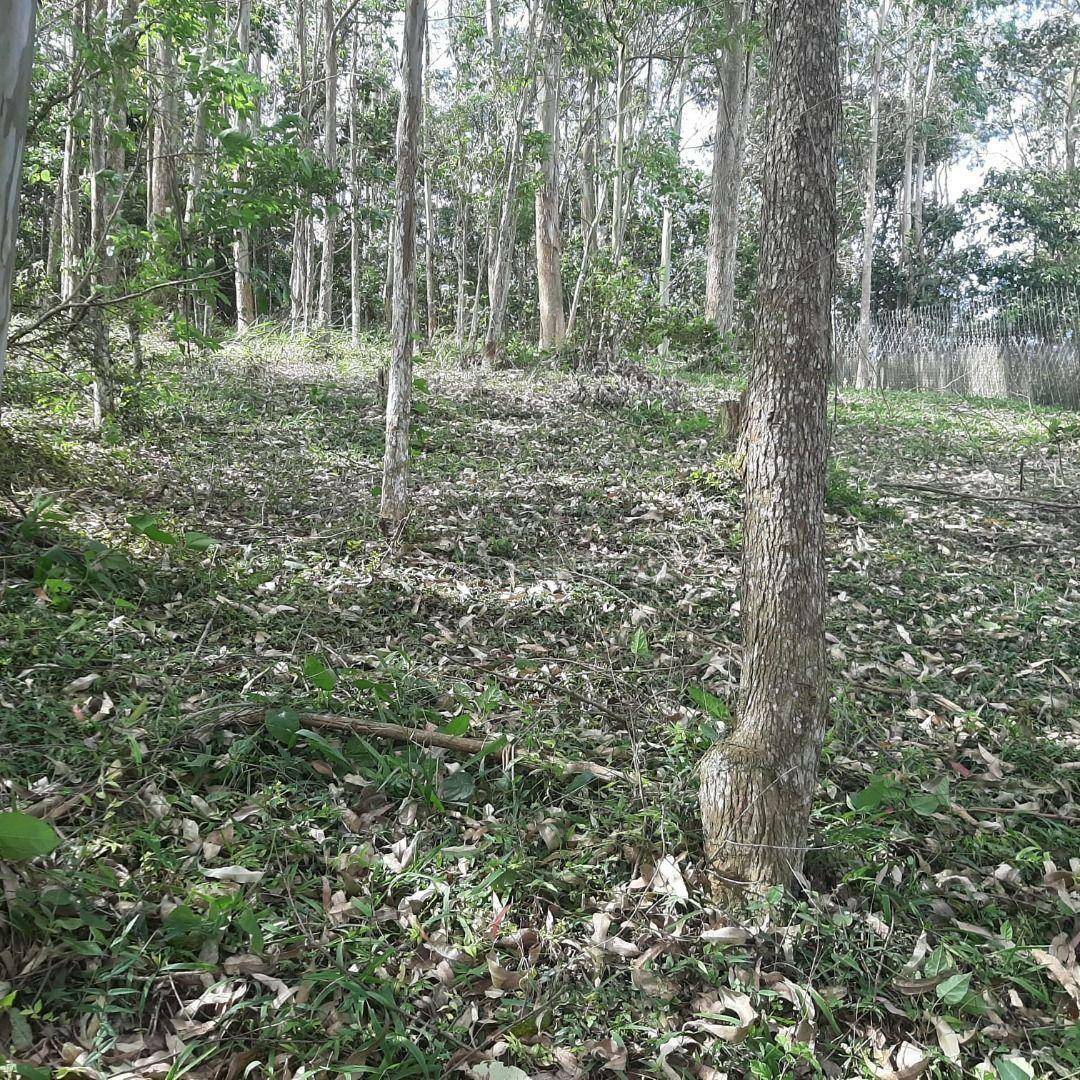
[[834, 286, 1080, 409]]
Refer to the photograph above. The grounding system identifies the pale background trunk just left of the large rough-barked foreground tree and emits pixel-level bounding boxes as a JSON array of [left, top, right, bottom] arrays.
[[705, 0, 750, 333]]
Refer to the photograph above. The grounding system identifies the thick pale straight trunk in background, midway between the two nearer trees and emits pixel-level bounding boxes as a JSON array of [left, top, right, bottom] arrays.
[[536, 0, 566, 349]]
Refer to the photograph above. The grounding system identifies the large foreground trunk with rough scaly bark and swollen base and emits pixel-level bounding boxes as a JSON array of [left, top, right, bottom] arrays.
[[700, 0, 839, 897]]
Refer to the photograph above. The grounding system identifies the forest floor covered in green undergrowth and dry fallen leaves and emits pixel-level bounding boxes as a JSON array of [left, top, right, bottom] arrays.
[[0, 336, 1080, 1080]]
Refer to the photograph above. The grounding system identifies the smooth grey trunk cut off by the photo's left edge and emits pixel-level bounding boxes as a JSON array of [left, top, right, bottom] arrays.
[[0, 0, 37, 401]]
